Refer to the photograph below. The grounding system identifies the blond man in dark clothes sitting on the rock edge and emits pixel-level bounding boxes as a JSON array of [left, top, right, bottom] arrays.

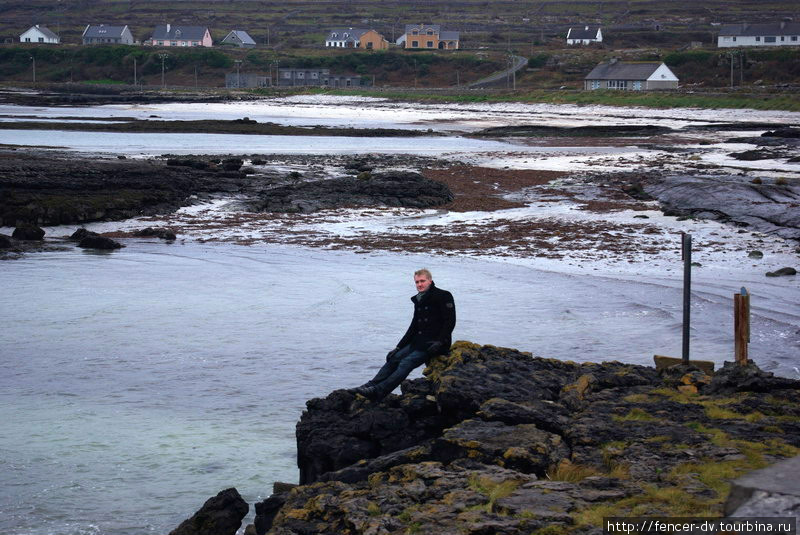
[[350, 269, 456, 401]]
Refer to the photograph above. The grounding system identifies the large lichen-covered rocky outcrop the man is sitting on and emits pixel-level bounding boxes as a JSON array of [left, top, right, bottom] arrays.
[[251, 342, 800, 535]]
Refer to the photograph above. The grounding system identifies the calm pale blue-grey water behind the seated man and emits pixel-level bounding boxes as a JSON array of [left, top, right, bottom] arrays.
[[0, 241, 800, 535]]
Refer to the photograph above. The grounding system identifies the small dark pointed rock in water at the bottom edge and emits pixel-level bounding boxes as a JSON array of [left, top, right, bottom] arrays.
[[170, 488, 250, 535]]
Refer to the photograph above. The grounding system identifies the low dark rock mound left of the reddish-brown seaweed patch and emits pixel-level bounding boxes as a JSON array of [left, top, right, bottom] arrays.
[[250, 171, 453, 213]]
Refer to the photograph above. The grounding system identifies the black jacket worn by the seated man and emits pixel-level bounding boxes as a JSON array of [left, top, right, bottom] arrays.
[[397, 282, 456, 355]]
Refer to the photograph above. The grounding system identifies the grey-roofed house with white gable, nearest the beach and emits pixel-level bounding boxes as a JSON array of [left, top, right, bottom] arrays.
[[583, 59, 678, 91]]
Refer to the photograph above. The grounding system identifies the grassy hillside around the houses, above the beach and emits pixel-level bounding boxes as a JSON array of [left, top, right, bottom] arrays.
[[0, 0, 800, 89]]
